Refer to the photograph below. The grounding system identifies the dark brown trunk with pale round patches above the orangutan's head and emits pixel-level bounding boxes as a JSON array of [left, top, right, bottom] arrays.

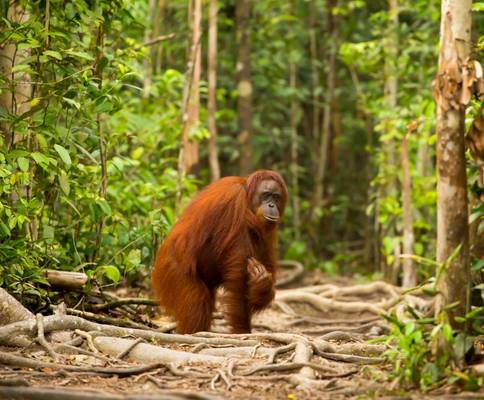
[[235, 0, 253, 176]]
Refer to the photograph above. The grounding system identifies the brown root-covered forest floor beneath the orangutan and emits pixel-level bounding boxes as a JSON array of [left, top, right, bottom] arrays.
[[0, 271, 484, 400]]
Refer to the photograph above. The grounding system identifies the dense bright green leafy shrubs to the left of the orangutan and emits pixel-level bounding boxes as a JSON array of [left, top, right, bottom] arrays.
[[0, 0, 197, 298]]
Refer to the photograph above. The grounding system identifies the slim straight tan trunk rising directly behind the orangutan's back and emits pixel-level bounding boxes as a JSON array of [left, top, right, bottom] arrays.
[[207, 0, 220, 182]]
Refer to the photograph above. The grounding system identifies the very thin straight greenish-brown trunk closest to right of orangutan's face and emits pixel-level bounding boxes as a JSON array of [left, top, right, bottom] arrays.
[[289, 60, 301, 240]]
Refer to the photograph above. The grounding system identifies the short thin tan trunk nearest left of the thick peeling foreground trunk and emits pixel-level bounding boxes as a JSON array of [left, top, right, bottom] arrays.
[[401, 131, 417, 288]]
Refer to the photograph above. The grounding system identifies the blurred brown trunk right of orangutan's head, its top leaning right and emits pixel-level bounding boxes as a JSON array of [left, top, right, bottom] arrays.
[[308, 0, 339, 220]]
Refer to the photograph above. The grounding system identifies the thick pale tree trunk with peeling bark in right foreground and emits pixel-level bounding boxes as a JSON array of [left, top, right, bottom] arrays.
[[434, 0, 472, 324]]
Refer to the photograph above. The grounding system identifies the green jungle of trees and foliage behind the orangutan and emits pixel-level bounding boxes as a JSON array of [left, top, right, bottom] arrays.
[[0, 0, 484, 398]]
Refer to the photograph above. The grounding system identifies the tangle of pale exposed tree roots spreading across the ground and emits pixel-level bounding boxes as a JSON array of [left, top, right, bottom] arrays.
[[0, 276, 438, 400]]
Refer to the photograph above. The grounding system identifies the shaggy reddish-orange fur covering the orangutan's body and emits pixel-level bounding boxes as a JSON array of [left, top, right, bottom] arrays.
[[152, 170, 287, 333]]
